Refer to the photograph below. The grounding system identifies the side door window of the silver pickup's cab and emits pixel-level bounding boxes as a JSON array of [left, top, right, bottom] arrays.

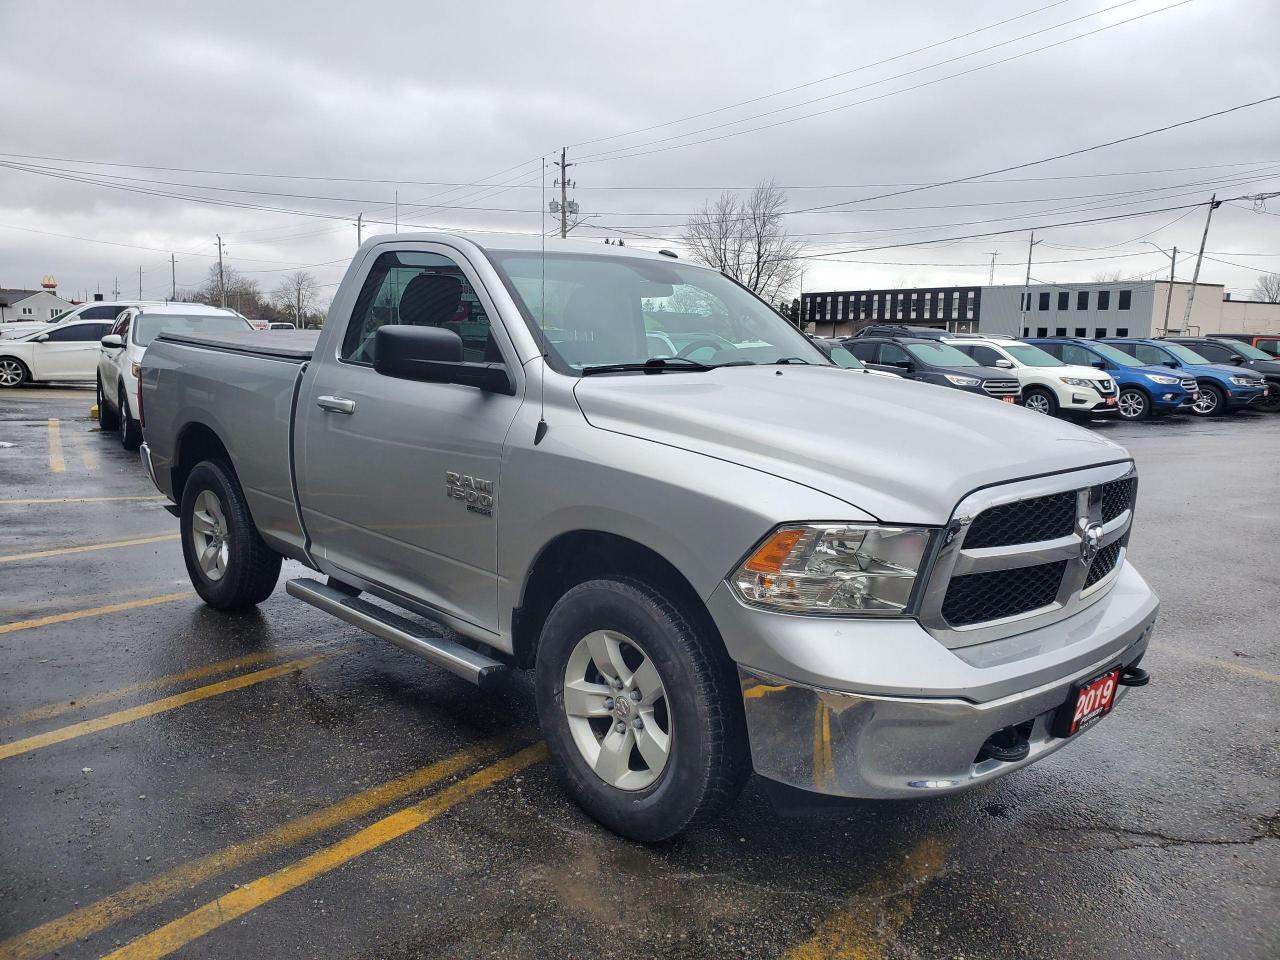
[[342, 251, 503, 365]]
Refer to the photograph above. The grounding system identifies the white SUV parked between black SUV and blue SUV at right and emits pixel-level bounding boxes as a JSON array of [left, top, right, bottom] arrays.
[[946, 335, 1116, 416]]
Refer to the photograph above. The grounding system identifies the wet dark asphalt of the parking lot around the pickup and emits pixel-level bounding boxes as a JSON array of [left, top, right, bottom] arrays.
[[0, 388, 1280, 960]]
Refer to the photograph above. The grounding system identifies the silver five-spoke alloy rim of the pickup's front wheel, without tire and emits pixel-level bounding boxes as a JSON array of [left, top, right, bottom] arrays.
[[564, 630, 672, 791]]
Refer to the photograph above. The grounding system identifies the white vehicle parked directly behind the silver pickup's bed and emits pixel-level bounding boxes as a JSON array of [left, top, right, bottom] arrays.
[[96, 303, 253, 451]]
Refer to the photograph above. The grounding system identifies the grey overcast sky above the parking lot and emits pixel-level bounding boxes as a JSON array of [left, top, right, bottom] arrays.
[[0, 0, 1280, 305]]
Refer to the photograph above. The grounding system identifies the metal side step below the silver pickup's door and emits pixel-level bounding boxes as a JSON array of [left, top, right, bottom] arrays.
[[284, 579, 507, 687]]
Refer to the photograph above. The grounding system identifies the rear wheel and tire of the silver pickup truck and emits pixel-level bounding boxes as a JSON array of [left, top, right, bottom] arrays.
[[179, 460, 280, 611]]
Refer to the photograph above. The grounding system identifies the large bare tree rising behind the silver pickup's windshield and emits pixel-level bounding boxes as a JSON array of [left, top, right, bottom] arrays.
[[684, 180, 801, 303]]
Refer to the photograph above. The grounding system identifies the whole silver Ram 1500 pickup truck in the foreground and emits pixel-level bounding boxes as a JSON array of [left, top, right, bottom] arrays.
[[137, 234, 1158, 841]]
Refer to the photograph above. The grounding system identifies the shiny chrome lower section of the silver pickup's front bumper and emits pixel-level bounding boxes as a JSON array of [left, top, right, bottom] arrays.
[[739, 609, 1156, 797]]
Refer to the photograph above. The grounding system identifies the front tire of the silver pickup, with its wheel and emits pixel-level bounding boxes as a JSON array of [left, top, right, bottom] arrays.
[[534, 579, 750, 842]]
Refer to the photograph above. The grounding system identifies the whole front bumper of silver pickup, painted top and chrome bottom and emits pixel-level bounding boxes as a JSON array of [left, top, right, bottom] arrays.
[[722, 564, 1158, 797]]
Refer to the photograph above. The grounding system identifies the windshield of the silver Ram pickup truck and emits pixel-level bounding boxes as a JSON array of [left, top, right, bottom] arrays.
[[489, 251, 831, 374]]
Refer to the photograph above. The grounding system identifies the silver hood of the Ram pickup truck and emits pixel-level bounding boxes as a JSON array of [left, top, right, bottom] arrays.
[[573, 366, 1129, 525]]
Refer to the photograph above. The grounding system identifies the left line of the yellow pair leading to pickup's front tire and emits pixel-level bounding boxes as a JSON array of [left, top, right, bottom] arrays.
[[0, 736, 515, 960]]
